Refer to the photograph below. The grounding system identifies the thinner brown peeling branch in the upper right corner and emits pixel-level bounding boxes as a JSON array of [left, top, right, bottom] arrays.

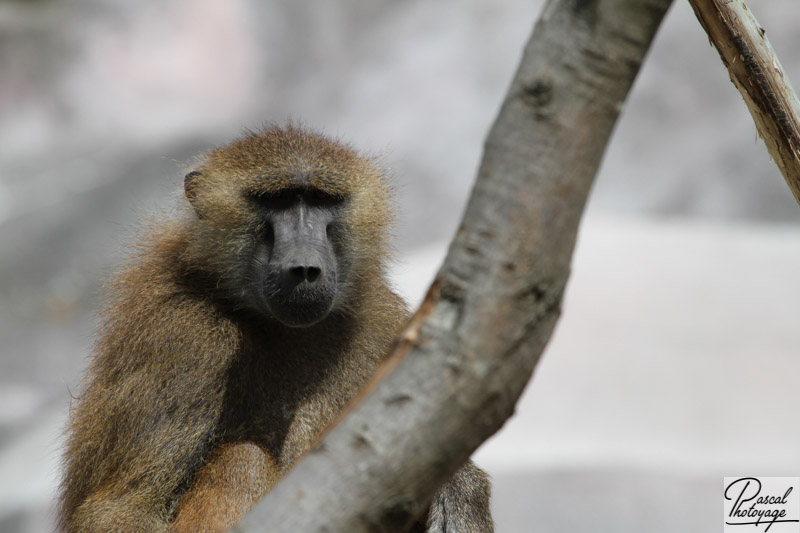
[[689, 0, 800, 203]]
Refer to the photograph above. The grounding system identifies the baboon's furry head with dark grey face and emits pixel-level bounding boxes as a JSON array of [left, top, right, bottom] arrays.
[[184, 125, 391, 327]]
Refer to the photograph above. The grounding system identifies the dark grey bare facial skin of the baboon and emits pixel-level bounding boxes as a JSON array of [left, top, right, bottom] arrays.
[[251, 188, 344, 327]]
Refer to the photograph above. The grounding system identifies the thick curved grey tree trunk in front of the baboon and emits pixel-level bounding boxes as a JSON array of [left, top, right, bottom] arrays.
[[235, 0, 671, 533]]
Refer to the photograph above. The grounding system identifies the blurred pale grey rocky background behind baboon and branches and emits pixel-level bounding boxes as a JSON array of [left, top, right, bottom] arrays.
[[0, 0, 800, 533]]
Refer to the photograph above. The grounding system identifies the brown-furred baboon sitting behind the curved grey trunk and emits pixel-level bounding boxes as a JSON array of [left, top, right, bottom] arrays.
[[60, 124, 493, 533]]
